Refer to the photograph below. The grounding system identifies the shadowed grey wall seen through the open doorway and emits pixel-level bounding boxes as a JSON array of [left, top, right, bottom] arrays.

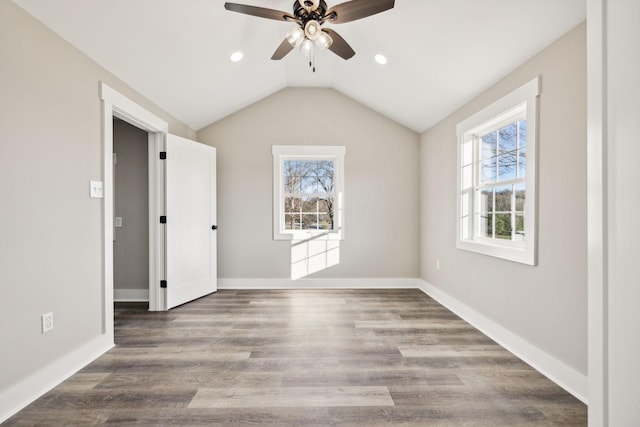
[[113, 120, 149, 292]]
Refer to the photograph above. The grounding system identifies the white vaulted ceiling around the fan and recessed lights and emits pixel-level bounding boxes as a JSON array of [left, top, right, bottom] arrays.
[[13, 0, 586, 132]]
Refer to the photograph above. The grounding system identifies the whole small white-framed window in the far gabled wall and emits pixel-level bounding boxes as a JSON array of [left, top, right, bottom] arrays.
[[272, 145, 345, 240]]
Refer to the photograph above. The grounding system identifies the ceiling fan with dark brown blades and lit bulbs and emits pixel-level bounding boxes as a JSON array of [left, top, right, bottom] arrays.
[[224, 0, 395, 65]]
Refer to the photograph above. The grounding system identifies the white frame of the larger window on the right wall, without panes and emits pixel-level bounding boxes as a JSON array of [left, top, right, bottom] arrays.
[[456, 77, 540, 265]]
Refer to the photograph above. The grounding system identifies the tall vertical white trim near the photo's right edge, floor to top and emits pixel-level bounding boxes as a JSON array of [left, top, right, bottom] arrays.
[[587, 0, 609, 427]]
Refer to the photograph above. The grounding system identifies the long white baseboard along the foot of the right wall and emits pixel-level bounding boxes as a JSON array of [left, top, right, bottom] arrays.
[[420, 280, 589, 404]]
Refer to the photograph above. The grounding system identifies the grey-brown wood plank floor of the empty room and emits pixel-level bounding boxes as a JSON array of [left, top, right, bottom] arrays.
[[6, 290, 587, 427]]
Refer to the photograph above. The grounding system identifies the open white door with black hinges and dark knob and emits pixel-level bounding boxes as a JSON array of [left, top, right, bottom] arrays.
[[165, 135, 217, 309]]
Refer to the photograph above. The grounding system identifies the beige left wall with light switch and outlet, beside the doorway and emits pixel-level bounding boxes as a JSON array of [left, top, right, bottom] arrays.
[[0, 0, 194, 406]]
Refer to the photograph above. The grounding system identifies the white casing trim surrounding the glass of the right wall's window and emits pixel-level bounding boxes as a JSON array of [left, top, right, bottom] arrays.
[[456, 77, 540, 265]]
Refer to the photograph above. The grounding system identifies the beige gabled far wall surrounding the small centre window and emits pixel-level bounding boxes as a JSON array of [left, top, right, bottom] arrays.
[[198, 88, 419, 279]]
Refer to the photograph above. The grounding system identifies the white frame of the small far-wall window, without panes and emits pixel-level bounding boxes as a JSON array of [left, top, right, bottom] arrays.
[[271, 145, 346, 240]]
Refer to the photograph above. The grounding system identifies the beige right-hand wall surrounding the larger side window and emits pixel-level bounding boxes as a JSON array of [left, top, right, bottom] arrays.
[[420, 24, 587, 375]]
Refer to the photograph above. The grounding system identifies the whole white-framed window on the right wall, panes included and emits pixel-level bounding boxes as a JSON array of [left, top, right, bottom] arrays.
[[457, 78, 539, 265]]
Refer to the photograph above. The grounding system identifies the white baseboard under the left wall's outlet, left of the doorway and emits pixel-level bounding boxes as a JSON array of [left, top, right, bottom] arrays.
[[0, 335, 114, 423]]
